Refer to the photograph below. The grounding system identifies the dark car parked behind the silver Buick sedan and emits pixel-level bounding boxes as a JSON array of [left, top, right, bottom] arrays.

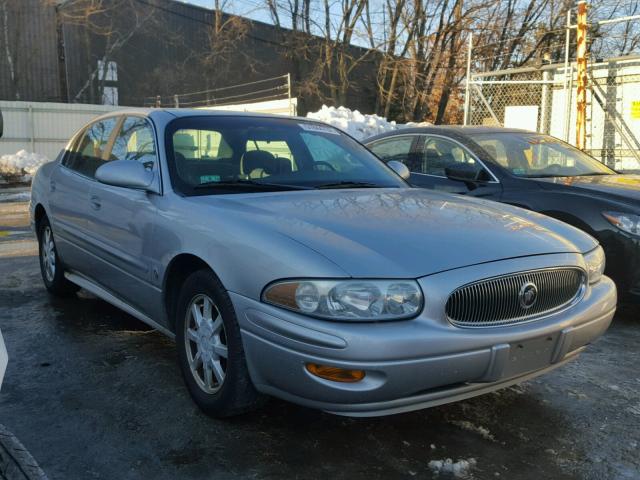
[[364, 126, 640, 301]]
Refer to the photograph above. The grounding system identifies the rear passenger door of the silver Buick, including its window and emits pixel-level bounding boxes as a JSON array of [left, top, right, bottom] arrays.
[[49, 117, 118, 273]]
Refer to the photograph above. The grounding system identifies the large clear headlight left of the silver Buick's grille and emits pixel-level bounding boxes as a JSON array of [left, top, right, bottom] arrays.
[[262, 279, 423, 321]]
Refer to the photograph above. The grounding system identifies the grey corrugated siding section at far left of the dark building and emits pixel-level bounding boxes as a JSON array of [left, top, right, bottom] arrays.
[[0, 0, 65, 101]]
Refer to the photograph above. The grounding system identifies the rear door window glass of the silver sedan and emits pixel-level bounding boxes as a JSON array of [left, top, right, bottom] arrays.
[[64, 117, 118, 178]]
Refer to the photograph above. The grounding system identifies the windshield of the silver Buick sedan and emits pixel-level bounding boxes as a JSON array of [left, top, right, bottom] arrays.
[[166, 115, 406, 195]]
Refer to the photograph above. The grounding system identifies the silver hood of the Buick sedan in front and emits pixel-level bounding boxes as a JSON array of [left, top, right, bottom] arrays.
[[192, 188, 596, 278]]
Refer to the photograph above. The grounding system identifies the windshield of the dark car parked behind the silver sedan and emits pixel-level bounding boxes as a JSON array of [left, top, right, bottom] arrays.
[[470, 132, 615, 178]]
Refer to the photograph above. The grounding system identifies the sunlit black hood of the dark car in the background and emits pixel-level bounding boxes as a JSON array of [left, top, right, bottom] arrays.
[[536, 174, 640, 202]]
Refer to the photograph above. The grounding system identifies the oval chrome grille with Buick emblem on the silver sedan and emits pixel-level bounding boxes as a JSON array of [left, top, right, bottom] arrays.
[[446, 268, 585, 327]]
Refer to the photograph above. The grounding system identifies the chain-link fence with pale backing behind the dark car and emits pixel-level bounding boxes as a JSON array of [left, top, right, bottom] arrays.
[[467, 57, 640, 171]]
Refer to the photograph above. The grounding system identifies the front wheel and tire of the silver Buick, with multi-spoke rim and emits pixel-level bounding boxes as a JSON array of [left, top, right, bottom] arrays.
[[175, 270, 262, 418]]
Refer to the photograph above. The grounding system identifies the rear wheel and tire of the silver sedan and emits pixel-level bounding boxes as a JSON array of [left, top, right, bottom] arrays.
[[38, 217, 80, 296]]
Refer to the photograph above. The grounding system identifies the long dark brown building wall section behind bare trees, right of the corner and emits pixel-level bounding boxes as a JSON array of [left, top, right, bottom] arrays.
[[60, 0, 376, 114]]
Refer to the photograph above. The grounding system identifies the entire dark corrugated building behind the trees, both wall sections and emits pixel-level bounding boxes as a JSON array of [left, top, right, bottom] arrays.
[[0, 0, 376, 114]]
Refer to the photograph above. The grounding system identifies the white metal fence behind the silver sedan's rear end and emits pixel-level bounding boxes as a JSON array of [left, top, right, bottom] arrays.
[[0, 101, 118, 159]]
